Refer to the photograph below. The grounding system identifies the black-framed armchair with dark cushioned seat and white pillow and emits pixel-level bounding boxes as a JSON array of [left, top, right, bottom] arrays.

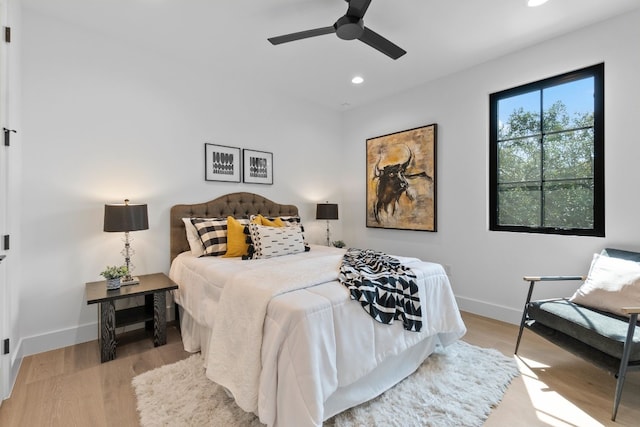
[[514, 249, 640, 421]]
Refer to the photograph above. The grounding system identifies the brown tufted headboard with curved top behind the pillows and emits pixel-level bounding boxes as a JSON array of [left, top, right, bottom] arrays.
[[169, 193, 298, 261]]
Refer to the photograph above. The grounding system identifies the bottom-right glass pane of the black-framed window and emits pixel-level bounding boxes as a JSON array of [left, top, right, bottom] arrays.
[[544, 180, 593, 229]]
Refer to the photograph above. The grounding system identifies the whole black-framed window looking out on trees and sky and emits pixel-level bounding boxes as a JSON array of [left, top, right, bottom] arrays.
[[489, 64, 604, 237]]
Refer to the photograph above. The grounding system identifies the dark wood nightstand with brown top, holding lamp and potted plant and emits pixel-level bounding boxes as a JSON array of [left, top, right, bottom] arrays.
[[86, 273, 178, 362]]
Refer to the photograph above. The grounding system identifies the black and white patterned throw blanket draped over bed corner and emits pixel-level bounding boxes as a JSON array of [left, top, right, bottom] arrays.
[[339, 248, 422, 332]]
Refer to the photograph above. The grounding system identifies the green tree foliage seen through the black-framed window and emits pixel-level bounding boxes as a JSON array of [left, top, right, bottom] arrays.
[[498, 101, 594, 228]]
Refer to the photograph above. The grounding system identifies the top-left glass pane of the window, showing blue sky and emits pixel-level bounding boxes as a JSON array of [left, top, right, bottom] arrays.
[[498, 90, 540, 140]]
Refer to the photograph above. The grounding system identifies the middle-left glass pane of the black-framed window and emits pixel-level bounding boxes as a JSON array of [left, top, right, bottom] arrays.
[[498, 138, 541, 183]]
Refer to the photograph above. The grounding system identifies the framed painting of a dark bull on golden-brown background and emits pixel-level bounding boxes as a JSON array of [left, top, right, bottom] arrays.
[[367, 124, 437, 231]]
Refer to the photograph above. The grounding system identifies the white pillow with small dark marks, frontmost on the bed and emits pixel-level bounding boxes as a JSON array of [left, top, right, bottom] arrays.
[[248, 223, 305, 258]]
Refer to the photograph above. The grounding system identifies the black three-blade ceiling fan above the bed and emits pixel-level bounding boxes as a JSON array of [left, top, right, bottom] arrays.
[[267, 0, 407, 59]]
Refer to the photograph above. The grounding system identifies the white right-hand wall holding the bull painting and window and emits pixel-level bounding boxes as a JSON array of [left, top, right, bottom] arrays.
[[343, 12, 640, 323]]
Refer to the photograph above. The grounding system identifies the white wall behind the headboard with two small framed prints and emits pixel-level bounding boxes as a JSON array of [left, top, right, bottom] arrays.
[[19, 9, 341, 355]]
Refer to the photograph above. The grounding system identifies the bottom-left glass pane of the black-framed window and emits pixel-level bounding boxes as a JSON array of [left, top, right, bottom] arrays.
[[498, 184, 541, 227]]
